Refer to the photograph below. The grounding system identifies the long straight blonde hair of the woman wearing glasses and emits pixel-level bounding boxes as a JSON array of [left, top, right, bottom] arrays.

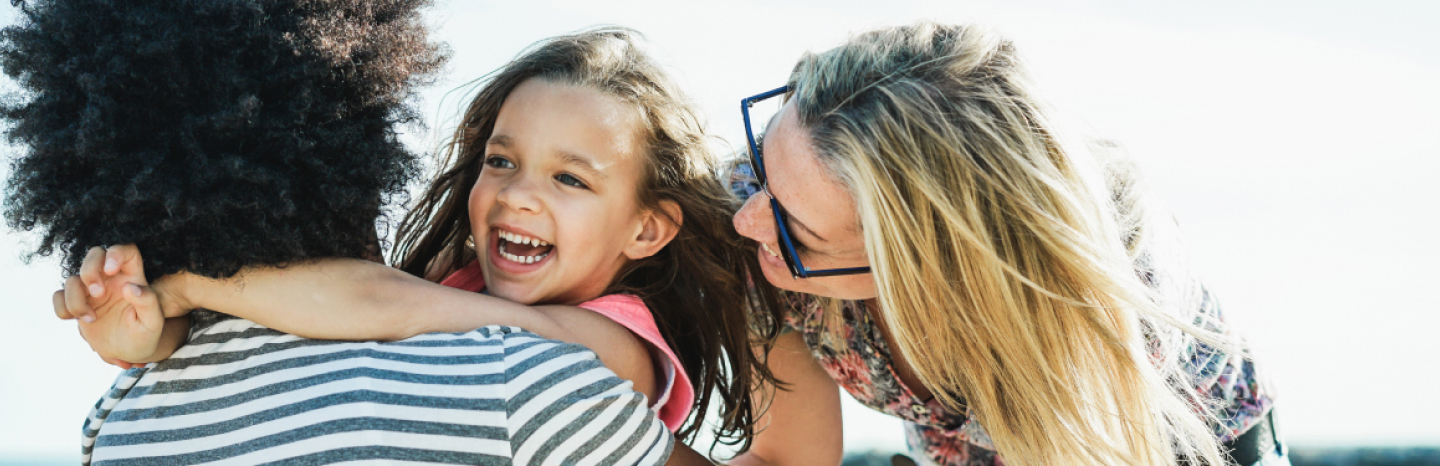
[[791, 23, 1228, 465]]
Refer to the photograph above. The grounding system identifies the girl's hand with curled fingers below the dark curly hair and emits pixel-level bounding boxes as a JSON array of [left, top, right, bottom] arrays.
[[55, 245, 166, 367]]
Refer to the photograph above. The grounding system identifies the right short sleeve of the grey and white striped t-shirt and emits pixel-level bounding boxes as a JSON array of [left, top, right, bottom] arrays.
[[505, 329, 675, 465]]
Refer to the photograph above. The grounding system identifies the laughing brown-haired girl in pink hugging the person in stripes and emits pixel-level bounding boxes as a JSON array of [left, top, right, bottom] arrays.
[[58, 29, 770, 448]]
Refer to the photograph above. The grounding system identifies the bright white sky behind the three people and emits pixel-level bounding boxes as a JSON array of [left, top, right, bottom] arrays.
[[0, 0, 1440, 460]]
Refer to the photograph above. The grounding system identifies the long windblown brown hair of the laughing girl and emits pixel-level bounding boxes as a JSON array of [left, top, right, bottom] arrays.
[[395, 27, 776, 450]]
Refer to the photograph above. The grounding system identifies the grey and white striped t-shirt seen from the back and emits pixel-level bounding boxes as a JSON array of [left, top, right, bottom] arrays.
[[82, 319, 674, 466]]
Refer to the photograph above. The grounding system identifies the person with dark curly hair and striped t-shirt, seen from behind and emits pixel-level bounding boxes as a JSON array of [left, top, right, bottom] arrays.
[[0, 0, 697, 465]]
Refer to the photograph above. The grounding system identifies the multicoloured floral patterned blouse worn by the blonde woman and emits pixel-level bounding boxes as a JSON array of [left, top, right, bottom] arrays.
[[730, 165, 1272, 466]]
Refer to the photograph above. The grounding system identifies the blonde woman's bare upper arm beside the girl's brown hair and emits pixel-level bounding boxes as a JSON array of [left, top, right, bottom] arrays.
[[730, 332, 844, 466]]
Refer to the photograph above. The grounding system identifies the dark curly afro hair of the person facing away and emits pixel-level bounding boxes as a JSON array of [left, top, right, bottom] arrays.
[[0, 0, 445, 279]]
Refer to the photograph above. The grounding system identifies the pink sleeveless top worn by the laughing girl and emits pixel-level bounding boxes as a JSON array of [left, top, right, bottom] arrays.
[[441, 260, 696, 431]]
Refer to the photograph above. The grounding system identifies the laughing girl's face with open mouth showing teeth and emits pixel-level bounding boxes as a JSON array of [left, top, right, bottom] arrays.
[[469, 79, 672, 305]]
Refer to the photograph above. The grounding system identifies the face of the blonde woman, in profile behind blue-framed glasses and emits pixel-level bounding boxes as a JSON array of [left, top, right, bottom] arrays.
[[734, 104, 877, 299]]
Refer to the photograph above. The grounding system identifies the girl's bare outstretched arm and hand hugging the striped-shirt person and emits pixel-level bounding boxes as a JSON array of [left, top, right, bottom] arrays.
[[56, 245, 657, 398]]
